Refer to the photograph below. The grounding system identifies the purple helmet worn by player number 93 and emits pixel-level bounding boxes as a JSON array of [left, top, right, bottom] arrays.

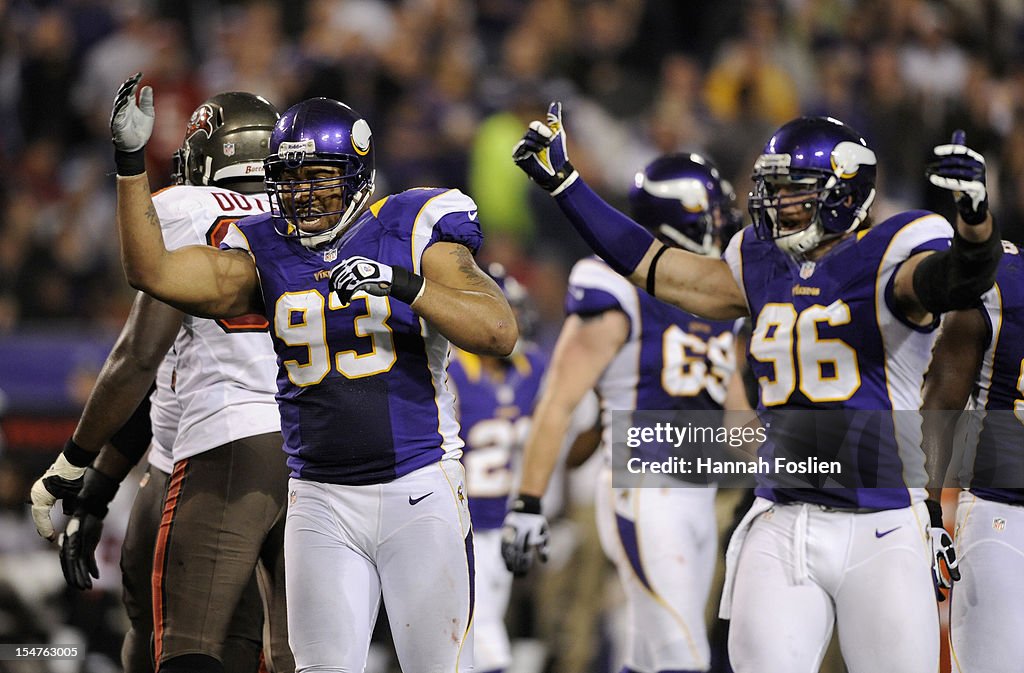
[[264, 98, 375, 247]]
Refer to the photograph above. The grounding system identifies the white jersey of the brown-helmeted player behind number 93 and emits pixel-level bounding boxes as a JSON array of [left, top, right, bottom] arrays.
[[154, 185, 281, 462]]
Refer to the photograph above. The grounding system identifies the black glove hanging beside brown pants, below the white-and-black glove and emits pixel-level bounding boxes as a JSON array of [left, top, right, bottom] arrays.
[[60, 467, 120, 590]]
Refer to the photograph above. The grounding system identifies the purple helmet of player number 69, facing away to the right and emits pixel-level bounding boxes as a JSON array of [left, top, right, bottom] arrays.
[[630, 154, 730, 255]]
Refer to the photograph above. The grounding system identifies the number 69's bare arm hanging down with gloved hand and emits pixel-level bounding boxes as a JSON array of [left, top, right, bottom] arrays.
[[502, 310, 630, 575]]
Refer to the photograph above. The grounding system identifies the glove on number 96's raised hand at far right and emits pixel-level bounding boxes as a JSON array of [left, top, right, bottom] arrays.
[[925, 130, 988, 224]]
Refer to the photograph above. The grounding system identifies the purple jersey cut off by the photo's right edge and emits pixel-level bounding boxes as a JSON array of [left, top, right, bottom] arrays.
[[969, 242, 1024, 505]]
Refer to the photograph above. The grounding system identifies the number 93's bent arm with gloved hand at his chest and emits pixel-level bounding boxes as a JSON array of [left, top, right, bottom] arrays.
[[331, 242, 519, 356]]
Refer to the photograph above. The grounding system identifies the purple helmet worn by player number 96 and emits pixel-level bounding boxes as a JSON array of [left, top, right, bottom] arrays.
[[749, 117, 878, 257]]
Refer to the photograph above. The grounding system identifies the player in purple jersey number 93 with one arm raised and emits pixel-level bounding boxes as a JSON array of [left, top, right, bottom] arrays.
[[111, 77, 518, 672]]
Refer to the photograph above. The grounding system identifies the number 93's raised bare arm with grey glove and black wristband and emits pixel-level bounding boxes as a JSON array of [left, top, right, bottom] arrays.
[[111, 73, 259, 318]]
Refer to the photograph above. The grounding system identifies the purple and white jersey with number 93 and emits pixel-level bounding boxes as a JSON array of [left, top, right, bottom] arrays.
[[221, 188, 482, 485]]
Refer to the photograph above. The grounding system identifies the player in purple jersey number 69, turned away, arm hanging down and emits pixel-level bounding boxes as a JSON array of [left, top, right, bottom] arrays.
[[503, 154, 735, 673]]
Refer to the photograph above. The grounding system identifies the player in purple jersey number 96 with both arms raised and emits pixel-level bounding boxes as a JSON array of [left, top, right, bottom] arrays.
[[513, 102, 1001, 673]]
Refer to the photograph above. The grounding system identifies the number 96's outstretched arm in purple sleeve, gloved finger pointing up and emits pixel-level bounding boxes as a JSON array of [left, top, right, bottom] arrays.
[[512, 102, 748, 320]]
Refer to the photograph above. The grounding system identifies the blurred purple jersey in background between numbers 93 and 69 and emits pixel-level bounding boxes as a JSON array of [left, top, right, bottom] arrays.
[[449, 345, 547, 531]]
